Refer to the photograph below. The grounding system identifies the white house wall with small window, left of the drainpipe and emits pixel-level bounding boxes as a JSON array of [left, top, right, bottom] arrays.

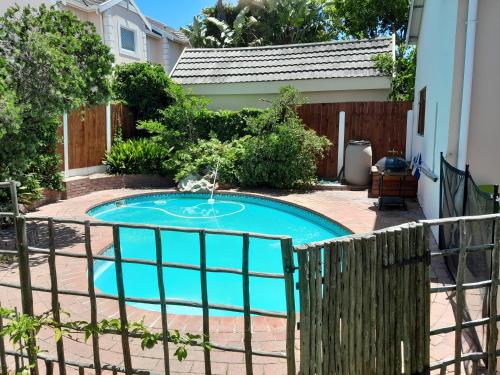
[[412, 0, 459, 222]]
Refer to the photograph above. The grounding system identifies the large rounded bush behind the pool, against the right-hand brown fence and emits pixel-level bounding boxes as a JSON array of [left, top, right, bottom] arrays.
[[236, 87, 330, 188]]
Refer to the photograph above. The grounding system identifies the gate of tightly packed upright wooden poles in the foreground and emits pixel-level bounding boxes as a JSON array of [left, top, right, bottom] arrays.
[[296, 224, 430, 375]]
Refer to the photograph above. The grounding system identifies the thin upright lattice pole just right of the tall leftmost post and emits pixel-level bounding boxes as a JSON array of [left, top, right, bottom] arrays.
[[47, 218, 66, 375]]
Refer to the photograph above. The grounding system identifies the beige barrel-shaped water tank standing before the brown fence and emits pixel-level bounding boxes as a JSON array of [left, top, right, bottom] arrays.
[[344, 140, 372, 186]]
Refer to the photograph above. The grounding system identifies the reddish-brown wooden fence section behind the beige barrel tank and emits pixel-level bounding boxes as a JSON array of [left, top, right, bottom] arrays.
[[299, 102, 412, 178]]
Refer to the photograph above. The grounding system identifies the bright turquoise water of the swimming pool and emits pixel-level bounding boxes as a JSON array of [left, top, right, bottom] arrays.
[[88, 193, 349, 316]]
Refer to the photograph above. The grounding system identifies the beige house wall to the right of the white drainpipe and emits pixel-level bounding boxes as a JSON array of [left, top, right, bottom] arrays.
[[467, 0, 500, 184]]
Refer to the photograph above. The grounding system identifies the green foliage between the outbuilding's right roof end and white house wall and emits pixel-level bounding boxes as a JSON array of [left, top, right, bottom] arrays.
[[374, 45, 417, 101]]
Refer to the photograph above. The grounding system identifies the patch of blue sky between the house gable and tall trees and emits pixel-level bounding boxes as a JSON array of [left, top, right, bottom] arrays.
[[136, 0, 223, 29]]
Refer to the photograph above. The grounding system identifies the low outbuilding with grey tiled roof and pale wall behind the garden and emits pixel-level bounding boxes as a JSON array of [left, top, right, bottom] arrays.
[[171, 37, 395, 109]]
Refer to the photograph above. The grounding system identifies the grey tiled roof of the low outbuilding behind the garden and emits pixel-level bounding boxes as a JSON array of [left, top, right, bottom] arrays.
[[172, 38, 393, 84]]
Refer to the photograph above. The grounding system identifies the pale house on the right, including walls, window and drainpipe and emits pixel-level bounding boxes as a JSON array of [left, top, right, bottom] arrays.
[[407, 0, 500, 222]]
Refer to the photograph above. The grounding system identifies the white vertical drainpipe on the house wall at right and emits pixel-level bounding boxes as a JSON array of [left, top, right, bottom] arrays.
[[457, 0, 478, 170]]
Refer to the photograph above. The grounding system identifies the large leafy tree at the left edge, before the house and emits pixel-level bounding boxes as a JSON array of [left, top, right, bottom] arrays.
[[0, 5, 113, 203]]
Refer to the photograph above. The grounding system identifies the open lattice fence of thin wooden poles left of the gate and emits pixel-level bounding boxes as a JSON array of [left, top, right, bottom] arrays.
[[0, 184, 296, 375]]
